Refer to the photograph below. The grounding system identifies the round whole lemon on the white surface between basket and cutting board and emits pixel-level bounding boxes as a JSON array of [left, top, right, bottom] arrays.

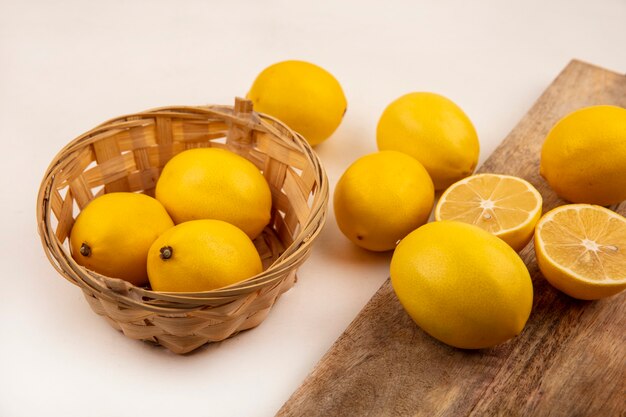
[[333, 151, 435, 251]]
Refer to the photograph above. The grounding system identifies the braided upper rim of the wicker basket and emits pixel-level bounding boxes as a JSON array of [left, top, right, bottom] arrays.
[[37, 104, 329, 313]]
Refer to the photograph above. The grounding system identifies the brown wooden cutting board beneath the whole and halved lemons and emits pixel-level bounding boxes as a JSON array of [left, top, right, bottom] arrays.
[[278, 61, 626, 416]]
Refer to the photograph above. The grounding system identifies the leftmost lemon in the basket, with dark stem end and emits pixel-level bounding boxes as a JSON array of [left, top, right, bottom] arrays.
[[70, 192, 174, 285]]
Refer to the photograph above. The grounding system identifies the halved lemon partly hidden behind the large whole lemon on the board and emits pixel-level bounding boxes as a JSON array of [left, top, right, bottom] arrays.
[[435, 174, 542, 251]]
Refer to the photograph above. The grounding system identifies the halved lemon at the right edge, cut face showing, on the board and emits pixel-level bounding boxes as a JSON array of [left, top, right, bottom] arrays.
[[535, 204, 626, 300]]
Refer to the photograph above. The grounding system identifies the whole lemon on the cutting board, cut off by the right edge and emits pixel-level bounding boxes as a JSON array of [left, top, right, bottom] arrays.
[[540, 106, 626, 206]]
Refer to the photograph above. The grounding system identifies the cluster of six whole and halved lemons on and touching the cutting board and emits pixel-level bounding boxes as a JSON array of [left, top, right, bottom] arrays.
[[334, 93, 626, 349]]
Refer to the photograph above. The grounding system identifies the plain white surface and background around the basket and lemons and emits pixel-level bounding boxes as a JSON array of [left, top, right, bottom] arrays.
[[0, 0, 626, 417]]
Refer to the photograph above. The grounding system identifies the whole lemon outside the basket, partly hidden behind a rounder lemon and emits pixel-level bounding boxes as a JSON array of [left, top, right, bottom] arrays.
[[376, 92, 480, 190]]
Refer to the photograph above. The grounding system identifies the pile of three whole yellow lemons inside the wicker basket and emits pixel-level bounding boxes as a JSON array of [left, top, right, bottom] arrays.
[[70, 148, 272, 292]]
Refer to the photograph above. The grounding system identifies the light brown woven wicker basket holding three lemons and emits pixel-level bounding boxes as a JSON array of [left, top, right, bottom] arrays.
[[37, 99, 328, 353]]
